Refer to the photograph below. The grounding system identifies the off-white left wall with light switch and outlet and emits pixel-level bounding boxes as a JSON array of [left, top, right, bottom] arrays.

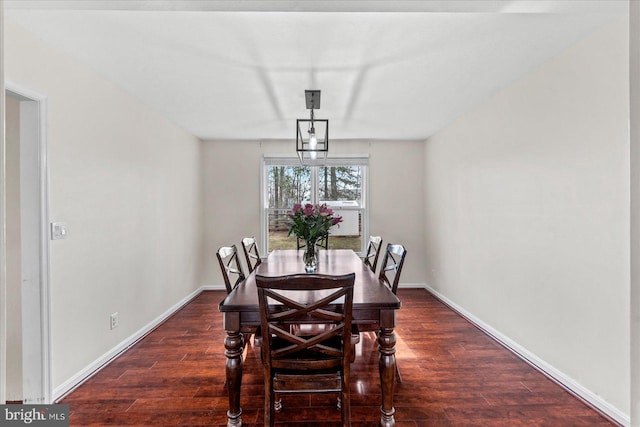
[[5, 22, 202, 388]]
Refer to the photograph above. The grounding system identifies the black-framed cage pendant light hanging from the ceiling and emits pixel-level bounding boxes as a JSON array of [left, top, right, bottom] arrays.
[[296, 90, 329, 165]]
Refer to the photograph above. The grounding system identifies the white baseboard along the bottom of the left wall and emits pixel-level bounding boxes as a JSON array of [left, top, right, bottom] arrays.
[[53, 286, 208, 402]]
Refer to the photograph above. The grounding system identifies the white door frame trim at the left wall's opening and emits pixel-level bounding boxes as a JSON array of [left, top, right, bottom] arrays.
[[5, 81, 53, 404]]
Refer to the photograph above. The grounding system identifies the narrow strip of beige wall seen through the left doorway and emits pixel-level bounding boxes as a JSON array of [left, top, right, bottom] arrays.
[[5, 97, 22, 401]]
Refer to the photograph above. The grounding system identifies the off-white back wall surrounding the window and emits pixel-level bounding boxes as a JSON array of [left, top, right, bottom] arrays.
[[202, 140, 425, 286]]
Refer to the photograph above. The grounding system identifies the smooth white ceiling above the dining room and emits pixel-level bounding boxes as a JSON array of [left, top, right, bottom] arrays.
[[5, 0, 628, 140]]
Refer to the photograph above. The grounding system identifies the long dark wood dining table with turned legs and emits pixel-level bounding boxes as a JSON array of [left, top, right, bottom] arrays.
[[218, 249, 401, 426]]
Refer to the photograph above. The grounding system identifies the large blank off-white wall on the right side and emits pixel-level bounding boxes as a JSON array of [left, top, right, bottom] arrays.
[[425, 19, 630, 417]]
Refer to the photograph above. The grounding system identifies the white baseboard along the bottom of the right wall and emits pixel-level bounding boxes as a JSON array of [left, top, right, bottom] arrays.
[[422, 285, 631, 427]]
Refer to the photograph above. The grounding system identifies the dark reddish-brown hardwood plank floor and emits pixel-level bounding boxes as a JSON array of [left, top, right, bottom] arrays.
[[60, 289, 615, 427]]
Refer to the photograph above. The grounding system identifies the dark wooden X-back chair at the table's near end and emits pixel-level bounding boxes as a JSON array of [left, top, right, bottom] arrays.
[[256, 273, 355, 427]]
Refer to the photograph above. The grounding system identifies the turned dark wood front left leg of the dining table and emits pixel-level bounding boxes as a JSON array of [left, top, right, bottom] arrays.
[[224, 331, 244, 427]]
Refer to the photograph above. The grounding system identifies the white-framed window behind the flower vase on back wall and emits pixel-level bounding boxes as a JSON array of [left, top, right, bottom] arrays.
[[261, 157, 368, 253]]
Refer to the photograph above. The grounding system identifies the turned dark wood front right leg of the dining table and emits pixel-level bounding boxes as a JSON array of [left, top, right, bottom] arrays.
[[378, 328, 396, 427]]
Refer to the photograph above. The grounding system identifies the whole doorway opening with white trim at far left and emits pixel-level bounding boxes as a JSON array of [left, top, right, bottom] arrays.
[[5, 82, 52, 404]]
